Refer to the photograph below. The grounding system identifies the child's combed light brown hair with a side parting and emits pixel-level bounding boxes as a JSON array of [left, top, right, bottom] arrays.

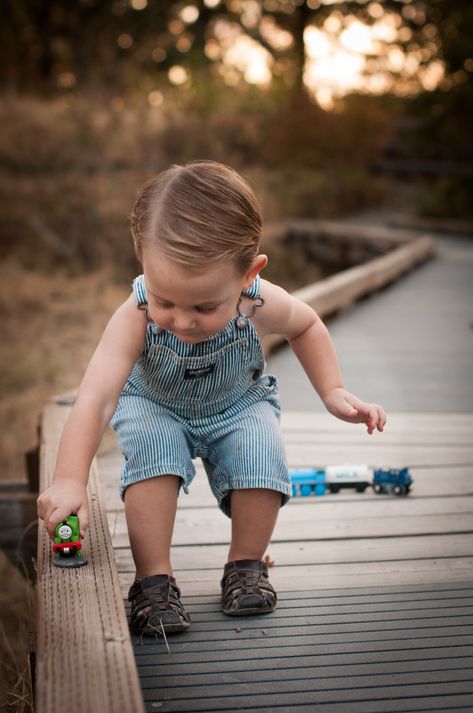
[[131, 161, 262, 274]]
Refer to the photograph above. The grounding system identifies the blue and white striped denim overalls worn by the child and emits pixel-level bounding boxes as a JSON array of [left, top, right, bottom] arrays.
[[111, 275, 291, 516]]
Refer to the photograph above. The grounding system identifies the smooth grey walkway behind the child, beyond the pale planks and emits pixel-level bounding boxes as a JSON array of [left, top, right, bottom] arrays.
[[268, 235, 473, 413]]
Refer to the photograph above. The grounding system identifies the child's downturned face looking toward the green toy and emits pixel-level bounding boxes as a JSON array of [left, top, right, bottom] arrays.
[[143, 248, 262, 344]]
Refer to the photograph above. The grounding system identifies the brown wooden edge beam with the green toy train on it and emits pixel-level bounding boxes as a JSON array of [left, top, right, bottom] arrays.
[[35, 404, 144, 713]]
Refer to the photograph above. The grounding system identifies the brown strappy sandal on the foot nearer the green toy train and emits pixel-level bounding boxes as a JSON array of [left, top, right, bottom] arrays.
[[128, 574, 190, 636]]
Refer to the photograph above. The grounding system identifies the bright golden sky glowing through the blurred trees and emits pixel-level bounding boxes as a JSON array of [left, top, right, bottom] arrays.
[[126, 0, 444, 109]]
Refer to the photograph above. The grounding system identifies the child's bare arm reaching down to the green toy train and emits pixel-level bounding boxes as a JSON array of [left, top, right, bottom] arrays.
[[38, 295, 146, 536]]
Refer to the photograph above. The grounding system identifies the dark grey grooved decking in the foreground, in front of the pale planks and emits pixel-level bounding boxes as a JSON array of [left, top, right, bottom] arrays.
[[130, 581, 473, 713]]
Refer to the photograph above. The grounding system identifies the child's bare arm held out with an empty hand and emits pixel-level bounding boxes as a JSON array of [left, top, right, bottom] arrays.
[[255, 281, 386, 433]]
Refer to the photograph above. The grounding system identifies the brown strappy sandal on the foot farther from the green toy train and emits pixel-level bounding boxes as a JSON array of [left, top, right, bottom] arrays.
[[221, 560, 277, 616]]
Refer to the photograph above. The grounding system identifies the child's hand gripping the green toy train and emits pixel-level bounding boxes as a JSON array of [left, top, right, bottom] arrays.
[[37, 478, 89, 539]]
